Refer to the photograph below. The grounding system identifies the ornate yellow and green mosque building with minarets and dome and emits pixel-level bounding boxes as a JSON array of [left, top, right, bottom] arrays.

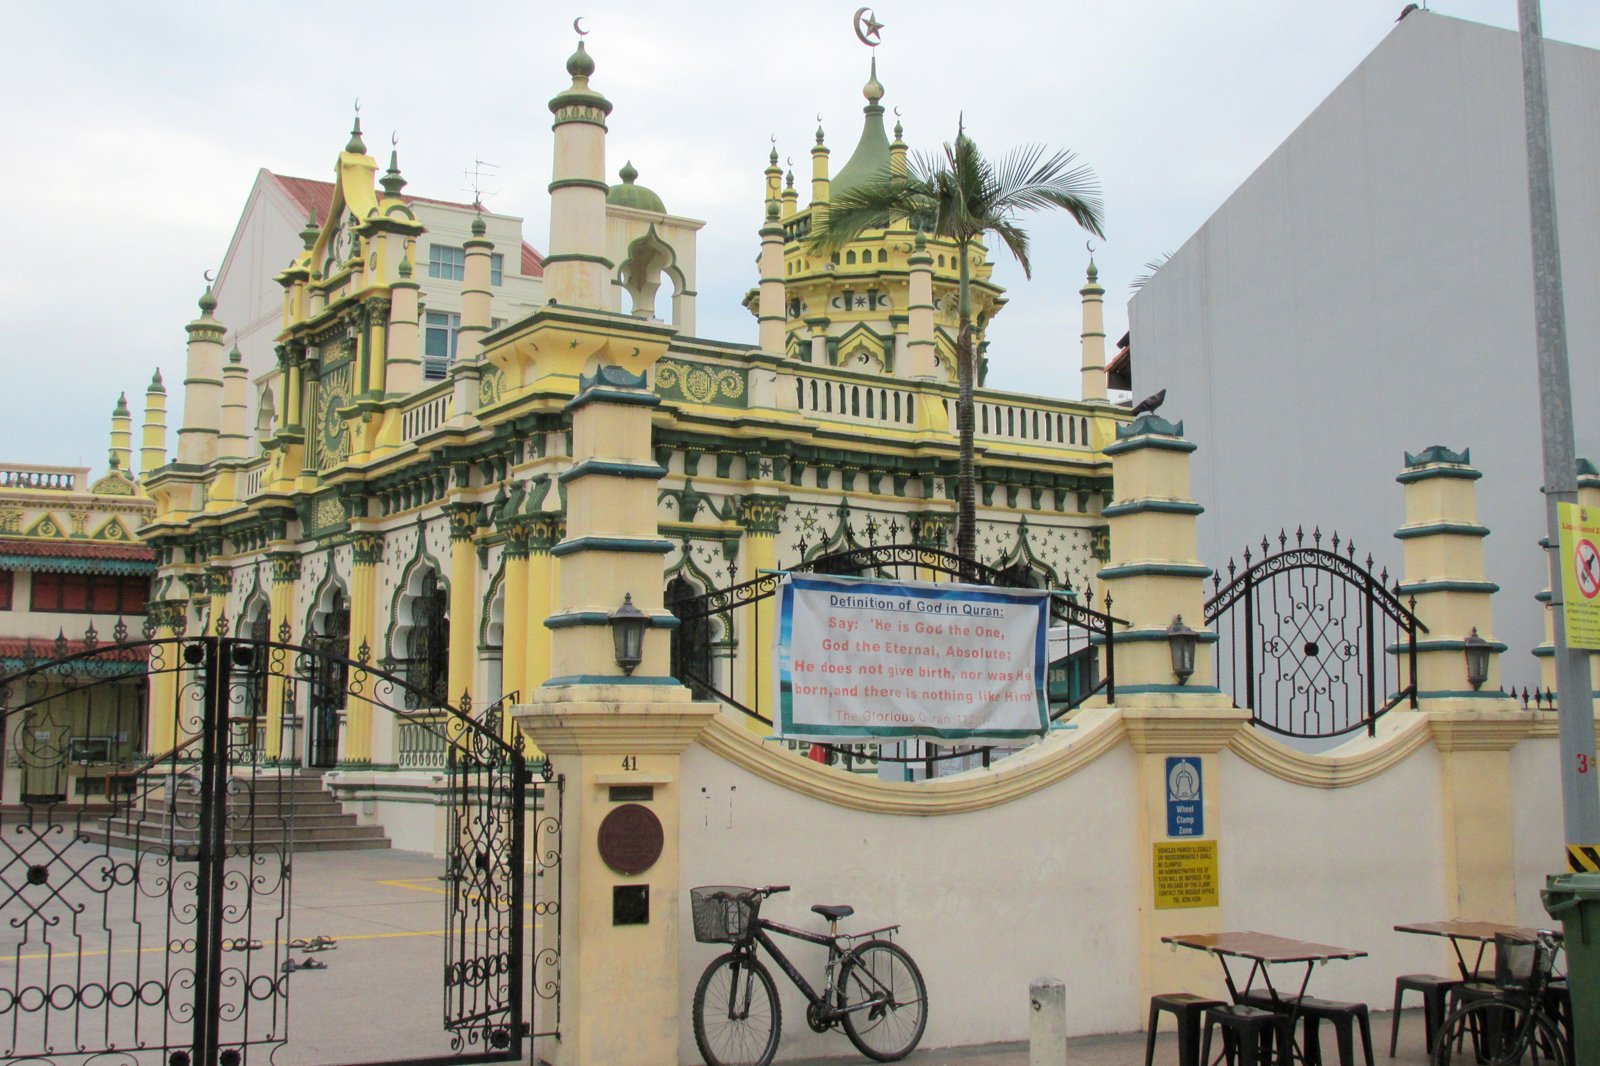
[[124, 31, 1126, 773]]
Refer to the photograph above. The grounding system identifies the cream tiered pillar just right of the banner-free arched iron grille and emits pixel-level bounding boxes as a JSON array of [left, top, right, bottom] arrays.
[[1395, 445, 1533, 922]]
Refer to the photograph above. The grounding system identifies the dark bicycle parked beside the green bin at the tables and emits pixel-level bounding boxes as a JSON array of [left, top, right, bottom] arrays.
[[1432, 930, 1571, 1066]]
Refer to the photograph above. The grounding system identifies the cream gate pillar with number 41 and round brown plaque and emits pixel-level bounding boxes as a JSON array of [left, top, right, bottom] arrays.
[[515, 364, 717, 1066]]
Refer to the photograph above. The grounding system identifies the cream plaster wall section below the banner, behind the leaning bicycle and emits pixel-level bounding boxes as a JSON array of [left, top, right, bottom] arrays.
[[678, 746, 1144, 1063]]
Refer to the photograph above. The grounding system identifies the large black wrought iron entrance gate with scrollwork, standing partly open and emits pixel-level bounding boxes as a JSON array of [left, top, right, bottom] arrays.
[[0, 623, 562, 1066]]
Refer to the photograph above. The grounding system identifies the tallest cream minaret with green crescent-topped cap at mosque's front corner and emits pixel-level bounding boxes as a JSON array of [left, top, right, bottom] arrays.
[[544, 40, 611, 311]]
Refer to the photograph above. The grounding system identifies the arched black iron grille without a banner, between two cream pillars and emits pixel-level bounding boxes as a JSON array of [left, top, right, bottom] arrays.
[[1205, 530, 1427, 738]]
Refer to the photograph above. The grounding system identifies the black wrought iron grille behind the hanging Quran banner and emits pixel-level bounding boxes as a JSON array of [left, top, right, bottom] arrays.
[[666, 544, 1126, 776]]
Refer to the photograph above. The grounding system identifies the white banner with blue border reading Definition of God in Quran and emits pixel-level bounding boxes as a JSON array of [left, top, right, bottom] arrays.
[[776, 575, 1050, 741]]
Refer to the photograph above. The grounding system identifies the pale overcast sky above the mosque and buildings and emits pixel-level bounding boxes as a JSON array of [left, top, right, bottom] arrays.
[[0, 0, 1600, 469]]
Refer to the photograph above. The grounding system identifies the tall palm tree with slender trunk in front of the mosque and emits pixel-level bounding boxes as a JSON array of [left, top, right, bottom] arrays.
[[811, 125, 1104, 559]]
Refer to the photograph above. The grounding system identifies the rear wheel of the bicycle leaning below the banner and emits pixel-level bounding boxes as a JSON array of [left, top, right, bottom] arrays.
[[838, 940, 928, 1063]]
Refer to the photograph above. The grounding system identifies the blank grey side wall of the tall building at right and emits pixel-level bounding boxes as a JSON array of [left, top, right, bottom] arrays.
[[1130, 11, 1600, 687]]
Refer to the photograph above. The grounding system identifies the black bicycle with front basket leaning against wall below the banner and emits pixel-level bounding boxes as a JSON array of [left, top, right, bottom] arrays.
[[690, 885, 928, 1066]]
